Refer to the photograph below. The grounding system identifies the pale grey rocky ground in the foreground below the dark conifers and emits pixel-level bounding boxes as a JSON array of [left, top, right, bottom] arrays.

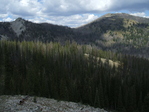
[[0, 96, 107, 112]]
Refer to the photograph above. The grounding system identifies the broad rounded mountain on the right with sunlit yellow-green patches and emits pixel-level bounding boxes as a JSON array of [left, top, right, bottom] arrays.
[[74, 13, 149, 57]]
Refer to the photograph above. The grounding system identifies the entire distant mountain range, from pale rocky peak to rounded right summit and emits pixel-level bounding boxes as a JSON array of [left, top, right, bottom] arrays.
[[0, 13, 149, 58]]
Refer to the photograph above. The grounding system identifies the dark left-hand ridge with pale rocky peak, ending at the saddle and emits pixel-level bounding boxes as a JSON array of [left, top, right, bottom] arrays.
[[0, 18, 72, 42]]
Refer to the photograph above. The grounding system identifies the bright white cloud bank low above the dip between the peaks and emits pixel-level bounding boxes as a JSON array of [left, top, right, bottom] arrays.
[[29, 14, 98, 27]]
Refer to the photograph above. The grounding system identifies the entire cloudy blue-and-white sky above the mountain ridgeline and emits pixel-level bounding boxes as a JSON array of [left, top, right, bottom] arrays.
[[0, 0, 149, 27]]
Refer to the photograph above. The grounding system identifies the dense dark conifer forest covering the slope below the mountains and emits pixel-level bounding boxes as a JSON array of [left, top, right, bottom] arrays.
[[0, 41, 149, 112]]
